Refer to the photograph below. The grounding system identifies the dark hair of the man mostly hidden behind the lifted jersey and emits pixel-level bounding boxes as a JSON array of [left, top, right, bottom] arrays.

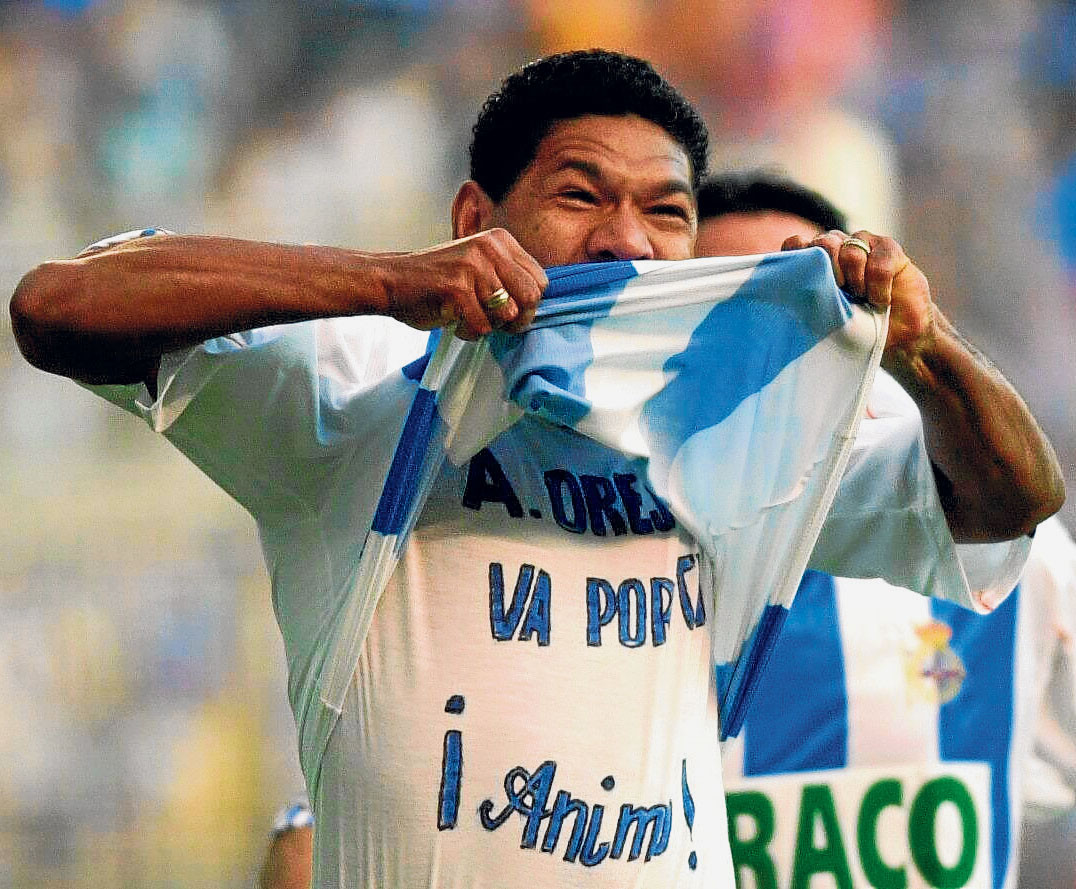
[[697, 170, 848, 231]]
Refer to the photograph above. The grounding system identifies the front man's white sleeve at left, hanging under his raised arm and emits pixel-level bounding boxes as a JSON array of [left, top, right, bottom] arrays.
[[87, 288, 428, 519]]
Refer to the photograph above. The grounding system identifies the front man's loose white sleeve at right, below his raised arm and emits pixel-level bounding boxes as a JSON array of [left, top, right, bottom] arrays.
[[808, 371, 1031, 611]]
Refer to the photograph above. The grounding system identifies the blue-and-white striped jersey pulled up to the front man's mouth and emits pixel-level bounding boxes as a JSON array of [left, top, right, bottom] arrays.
[[316, 249, 887, 762]]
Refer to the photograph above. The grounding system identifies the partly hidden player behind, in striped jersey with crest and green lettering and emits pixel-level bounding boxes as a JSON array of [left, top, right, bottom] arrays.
[[695, 172, 1076, 889]]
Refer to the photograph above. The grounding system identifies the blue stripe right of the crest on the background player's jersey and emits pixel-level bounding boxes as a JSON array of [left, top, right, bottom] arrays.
[[931, 587, 1020, 889]]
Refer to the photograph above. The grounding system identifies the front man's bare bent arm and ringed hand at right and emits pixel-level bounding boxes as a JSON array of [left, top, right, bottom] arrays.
[[783, 231, 1064, 542]]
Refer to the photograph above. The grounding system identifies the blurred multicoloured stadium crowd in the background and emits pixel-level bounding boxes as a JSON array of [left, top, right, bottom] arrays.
[[0, 0, 1076, 889]]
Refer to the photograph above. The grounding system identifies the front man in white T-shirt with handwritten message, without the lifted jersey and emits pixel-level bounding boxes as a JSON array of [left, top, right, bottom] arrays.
[[12, 51, 1063, 889]]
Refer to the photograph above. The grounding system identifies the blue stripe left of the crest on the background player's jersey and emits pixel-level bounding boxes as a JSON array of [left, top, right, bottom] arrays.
[[744, 570, 848, 775]]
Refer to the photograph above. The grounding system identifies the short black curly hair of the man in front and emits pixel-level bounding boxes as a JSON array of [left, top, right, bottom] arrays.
[[470, 50, 709, 203]]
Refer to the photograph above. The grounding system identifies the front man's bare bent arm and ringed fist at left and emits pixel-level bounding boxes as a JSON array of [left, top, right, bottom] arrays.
[[11, 229, 547, 390]]
